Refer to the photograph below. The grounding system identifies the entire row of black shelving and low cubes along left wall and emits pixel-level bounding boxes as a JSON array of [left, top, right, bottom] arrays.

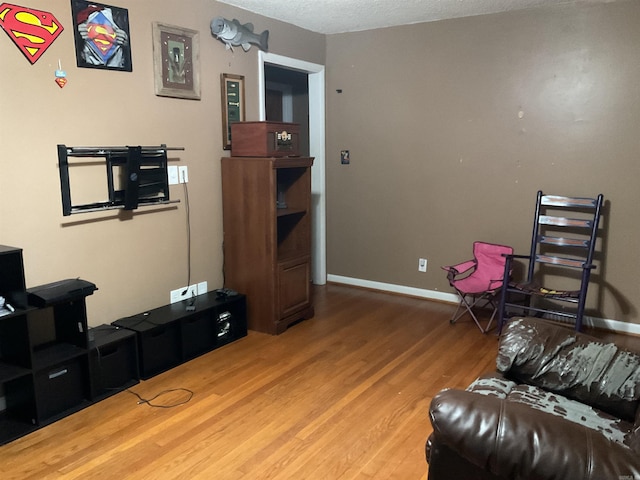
[[0, 245, 247, 445]]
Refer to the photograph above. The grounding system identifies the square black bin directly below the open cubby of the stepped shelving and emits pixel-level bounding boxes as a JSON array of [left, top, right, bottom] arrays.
[[35, 357, 86, 422]]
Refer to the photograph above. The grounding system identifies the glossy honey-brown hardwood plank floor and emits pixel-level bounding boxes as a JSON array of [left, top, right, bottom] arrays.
[[0, 285, 498, 480]]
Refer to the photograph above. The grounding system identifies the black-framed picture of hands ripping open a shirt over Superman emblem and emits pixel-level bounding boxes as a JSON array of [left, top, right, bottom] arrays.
[[71, 0, 133, 72]]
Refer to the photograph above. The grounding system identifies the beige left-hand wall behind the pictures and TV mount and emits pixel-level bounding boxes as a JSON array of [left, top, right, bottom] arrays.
[[0, 0, 325, 325]]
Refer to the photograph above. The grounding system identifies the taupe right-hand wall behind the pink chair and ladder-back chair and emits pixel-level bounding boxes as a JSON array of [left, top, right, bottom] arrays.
[[327, 1, 640, 323]]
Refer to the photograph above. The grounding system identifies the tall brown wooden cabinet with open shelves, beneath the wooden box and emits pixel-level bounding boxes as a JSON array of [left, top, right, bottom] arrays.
[[222, 157, 313, 334]]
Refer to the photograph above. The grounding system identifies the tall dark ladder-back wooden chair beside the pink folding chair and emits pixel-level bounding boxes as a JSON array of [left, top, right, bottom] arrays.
[[498, 191, 603, 331]]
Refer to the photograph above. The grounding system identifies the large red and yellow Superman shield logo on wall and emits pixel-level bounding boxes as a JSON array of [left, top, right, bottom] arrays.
[[0, 3, 64, 64]]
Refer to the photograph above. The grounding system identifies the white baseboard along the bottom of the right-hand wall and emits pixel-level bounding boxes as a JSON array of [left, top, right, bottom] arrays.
[[327, 274, 640, 335]]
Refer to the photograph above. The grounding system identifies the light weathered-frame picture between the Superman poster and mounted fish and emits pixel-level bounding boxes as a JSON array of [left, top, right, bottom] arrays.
[[152, 22, 200, 100]]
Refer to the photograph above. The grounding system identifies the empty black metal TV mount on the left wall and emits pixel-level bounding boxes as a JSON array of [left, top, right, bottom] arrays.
[[58, 144, 184, 216]]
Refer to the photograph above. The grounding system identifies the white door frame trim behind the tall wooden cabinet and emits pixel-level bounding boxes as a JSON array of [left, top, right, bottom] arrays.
[[258, 51, 327, 285]]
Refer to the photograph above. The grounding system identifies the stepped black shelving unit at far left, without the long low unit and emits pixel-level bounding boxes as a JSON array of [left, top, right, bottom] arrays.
[[0, 245, 139, 445]]
